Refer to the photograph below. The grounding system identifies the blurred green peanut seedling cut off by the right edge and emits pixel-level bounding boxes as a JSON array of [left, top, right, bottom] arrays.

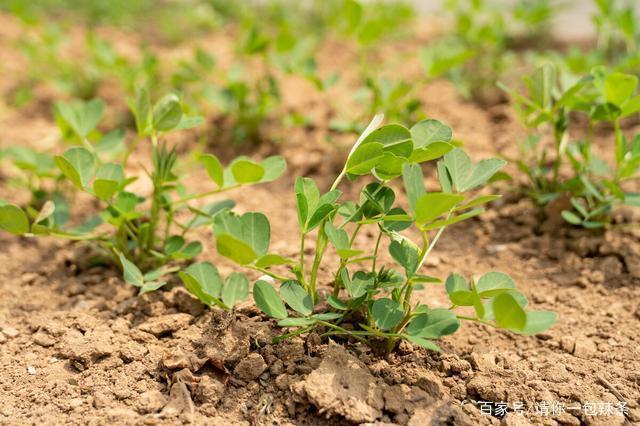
[[503, 63, 640, 228]]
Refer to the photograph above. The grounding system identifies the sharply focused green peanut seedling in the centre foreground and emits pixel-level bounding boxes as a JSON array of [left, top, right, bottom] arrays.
[[190, 116, 555, 351]]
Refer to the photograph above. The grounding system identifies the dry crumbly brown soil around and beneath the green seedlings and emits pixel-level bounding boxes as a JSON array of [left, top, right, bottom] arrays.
[[0, 11, 640, 425]]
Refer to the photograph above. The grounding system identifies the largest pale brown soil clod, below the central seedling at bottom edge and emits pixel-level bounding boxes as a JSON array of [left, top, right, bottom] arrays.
[[291, 346, 384, 423]]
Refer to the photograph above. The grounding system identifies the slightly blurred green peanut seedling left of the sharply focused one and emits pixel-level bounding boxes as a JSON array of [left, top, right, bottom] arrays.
[[0, 90, 286, 307]]
